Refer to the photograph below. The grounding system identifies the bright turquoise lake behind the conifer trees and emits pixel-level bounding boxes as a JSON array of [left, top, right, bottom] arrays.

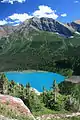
[[5, 72, 65, 92]]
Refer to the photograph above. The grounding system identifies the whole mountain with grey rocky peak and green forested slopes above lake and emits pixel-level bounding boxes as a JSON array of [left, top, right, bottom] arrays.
[[0, 17, 80, 72]]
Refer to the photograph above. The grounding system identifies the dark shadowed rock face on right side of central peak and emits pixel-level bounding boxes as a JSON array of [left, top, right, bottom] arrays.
[[31, 18, 73, 37]]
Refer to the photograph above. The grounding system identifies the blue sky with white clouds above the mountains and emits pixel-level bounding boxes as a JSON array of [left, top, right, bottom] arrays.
[[0, 0, 80, 26]]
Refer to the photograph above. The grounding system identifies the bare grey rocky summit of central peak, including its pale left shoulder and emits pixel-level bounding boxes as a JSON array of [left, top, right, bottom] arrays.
[[14, 17, 74, 37]]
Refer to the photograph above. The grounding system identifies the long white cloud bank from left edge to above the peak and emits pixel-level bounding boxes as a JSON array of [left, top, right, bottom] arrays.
[[0, 5, 58, 25]]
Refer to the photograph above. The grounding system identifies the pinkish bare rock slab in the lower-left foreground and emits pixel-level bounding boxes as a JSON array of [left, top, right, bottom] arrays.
[[0, 94, 35, 120]]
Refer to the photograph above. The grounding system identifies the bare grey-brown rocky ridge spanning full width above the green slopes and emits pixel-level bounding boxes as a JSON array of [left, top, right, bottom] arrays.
[[0, 17, 80, 37]]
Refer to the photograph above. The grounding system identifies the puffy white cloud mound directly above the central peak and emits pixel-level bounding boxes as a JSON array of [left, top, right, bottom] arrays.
[[33, 5, 58, 19]]
